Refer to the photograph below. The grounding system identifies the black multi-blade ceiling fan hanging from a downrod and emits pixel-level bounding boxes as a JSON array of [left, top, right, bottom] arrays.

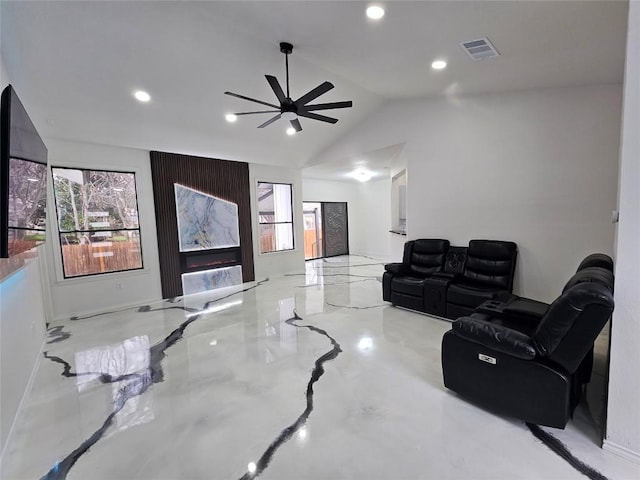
[[224, 42, 353, 132]]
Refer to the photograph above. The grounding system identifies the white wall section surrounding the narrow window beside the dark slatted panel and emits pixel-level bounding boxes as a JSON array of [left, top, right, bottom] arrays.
[[249, 163, 304, 280]]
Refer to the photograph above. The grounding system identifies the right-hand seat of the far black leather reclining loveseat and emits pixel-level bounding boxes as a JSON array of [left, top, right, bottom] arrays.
[[447, 240, 518, 319]]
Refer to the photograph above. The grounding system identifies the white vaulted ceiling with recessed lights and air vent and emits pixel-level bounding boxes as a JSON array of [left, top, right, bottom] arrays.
[[0, 0, 628, 179]]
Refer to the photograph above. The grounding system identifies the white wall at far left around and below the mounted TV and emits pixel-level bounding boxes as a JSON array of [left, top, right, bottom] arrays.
[[0, 57, 46, 456]]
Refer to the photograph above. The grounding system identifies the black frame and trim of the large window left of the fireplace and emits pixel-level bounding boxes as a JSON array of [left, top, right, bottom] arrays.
[[50, 165, 146, 281]]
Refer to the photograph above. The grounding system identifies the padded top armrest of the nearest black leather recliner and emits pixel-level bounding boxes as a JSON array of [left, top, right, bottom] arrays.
[[452, 317, 536, 360]]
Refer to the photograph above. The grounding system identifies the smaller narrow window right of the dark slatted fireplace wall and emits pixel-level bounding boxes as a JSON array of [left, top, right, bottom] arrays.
[[258, 182, 293, 253]]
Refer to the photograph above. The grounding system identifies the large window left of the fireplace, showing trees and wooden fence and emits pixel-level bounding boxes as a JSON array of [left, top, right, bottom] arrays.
[[51, 167, 142, 278]]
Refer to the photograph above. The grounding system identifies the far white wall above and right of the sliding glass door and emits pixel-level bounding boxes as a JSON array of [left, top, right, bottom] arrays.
[[302, 178, 405, 260]]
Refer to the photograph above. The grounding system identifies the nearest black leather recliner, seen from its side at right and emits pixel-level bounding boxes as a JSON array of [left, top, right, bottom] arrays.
[[442, 254, 614, 428]]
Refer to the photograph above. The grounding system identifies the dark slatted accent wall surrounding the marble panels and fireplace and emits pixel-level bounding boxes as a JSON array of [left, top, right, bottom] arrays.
[[151, 152, 255, 298]]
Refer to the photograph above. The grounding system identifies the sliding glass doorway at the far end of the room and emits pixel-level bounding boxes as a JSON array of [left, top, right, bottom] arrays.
[[302, 202, 349, 260]]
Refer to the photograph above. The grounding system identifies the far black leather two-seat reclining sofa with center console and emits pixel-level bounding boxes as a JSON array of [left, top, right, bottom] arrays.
[[382, 239, 518, 319]]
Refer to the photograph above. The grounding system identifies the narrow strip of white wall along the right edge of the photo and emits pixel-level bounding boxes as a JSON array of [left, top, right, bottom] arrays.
[[604, 1, 640, 462]]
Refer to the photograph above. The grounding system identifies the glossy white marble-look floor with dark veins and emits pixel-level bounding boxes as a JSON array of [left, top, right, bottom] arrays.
[[2, 256, 640, 480]]
